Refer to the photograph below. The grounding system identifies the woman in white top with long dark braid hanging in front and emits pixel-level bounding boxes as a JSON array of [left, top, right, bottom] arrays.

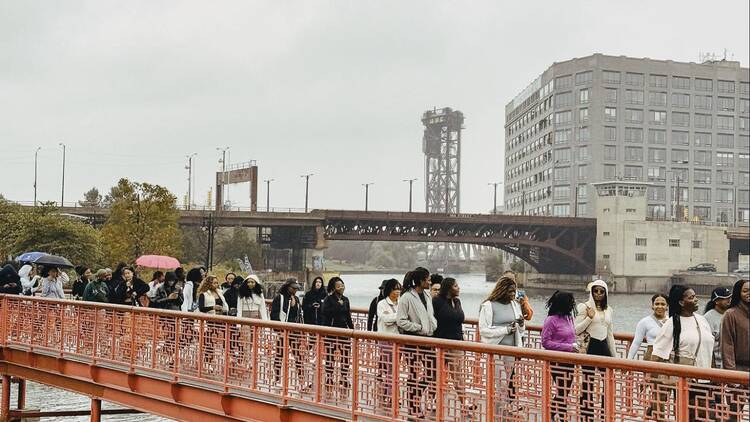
[[651, 284, 714, 420]]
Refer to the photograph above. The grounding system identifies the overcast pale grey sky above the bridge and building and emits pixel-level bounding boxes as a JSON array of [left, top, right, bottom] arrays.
[[0, 0, 750, 212]]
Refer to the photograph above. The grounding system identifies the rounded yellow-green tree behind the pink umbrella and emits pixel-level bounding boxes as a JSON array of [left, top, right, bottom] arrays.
[[102, 179, 182, 263]]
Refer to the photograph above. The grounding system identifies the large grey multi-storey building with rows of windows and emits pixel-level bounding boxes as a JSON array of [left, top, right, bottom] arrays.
[[504, 54, 750, 224]]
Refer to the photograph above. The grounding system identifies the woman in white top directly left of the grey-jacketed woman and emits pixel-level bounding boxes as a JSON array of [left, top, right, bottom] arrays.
[[377, 278, 401, 408]]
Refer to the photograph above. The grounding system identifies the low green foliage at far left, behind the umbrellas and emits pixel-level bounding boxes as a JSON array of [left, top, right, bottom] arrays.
[[0, 200, 102, 266]]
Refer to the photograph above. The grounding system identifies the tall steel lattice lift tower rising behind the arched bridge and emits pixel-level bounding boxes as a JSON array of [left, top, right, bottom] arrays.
[[422, 107, 471, 271]]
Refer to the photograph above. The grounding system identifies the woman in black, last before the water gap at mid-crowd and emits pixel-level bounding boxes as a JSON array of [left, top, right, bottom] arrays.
[[323, 277, 354, 395]]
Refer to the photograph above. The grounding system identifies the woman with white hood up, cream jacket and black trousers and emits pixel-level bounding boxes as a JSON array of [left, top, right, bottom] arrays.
[[575, 280, 615, 420]]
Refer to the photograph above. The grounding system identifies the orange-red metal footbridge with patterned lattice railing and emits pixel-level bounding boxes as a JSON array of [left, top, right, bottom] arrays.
[[0, 295, 750, 422]]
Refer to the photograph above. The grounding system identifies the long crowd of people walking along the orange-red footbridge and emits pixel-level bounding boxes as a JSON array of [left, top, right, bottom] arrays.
[[0, 263, 750, 420]]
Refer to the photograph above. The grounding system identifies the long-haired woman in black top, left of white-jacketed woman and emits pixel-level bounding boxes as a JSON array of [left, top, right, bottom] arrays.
[[432, 277, 473, 417]]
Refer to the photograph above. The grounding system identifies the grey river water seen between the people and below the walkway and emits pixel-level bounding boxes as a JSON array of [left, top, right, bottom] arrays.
[[0, 274, 668, 422]]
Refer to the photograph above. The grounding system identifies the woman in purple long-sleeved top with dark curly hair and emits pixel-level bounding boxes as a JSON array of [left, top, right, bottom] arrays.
[[542, 290, 578, 421]]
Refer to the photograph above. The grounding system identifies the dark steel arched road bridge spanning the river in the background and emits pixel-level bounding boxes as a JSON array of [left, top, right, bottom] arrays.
[[53, 207, 596, 274]]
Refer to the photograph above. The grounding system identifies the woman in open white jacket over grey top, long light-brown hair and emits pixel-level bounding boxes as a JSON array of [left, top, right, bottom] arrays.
[[479, 277, 524, 416]]
